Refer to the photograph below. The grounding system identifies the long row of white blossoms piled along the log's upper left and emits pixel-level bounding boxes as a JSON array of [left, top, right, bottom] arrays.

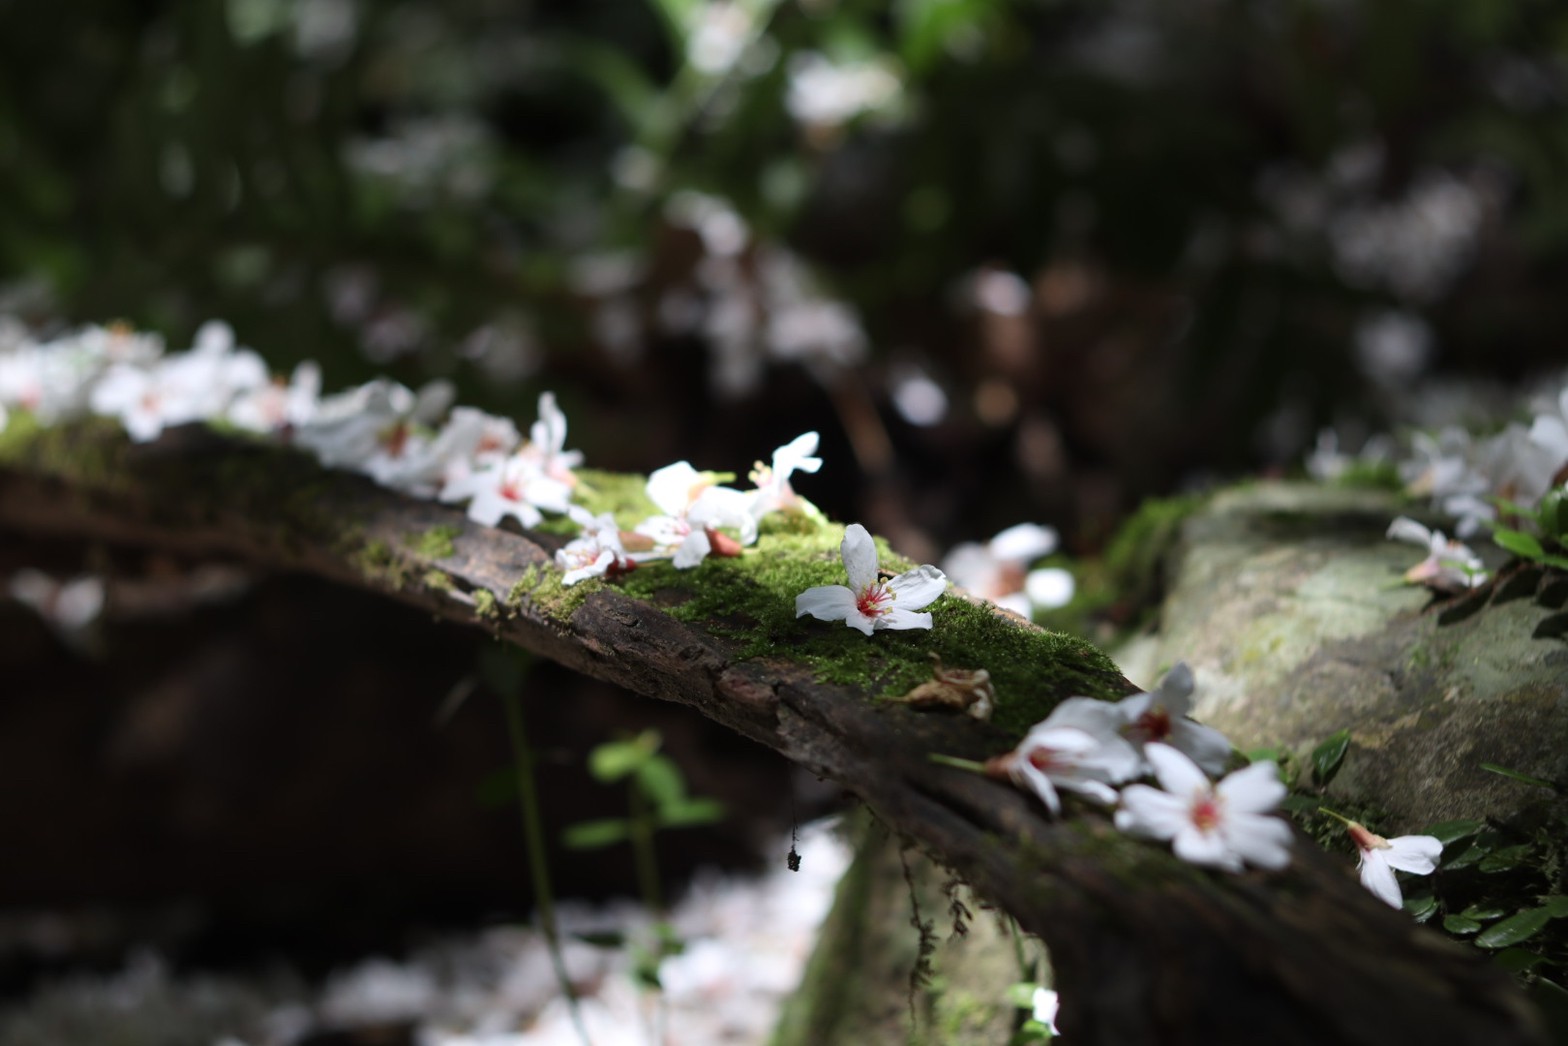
[[0, 321, 822, 585]]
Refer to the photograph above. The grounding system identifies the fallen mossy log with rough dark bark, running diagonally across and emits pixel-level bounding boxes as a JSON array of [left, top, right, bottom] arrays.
[[0, 420, 1544, 1046]]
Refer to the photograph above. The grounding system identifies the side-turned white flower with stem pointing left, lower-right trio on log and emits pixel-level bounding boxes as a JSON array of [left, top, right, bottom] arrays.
[[986, 698, 1142, 814]]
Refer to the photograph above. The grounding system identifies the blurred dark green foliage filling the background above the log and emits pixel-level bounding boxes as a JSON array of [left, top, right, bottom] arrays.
[[0, 0, 1568, 518]]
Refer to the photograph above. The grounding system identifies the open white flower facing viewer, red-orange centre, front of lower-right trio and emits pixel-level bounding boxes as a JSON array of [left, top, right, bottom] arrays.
[[1116, 743, 1290, 872]]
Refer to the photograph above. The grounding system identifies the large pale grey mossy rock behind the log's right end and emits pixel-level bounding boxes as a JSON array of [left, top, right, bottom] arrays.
[[1123, 483, 1568, 833]]
